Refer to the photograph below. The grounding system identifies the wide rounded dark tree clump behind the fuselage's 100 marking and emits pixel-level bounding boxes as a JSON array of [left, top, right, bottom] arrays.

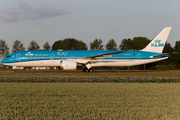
[[52, 38, 87, 50]]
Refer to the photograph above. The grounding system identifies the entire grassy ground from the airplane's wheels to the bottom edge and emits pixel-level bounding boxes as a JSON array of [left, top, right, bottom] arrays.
[[0, 70, 180, 120]]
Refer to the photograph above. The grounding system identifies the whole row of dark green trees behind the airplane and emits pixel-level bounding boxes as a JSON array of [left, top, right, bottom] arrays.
[[0, 37, 180, 70]]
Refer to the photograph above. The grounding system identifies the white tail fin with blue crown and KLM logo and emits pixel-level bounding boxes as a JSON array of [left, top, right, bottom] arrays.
[[142, 27, 172, 53]]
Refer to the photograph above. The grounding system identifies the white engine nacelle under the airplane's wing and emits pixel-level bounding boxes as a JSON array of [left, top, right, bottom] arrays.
[[60, 60, 77, 70]]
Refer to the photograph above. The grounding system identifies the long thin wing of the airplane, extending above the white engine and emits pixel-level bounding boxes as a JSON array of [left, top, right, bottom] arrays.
[[77, 50, 128, 64]]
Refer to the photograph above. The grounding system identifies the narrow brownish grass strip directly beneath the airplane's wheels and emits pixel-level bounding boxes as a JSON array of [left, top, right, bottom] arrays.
[[0, 70, 180, 77]]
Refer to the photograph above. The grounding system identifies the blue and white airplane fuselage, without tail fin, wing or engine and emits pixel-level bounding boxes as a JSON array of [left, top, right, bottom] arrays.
[[1, 50, 168, 67]]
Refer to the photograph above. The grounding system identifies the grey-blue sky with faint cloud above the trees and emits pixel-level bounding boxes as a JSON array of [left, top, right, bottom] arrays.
[[0, 0, 180, 52]]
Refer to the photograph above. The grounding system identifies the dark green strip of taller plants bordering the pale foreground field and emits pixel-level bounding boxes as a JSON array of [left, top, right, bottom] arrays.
[[0, 75, 180, 83]]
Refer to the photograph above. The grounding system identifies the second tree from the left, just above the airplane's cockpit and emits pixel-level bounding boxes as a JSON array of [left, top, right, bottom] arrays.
[[12, 39, 26, 52]]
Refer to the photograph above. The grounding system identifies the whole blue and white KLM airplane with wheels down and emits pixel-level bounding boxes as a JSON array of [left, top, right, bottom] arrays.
[[1, 27, 172, 72]]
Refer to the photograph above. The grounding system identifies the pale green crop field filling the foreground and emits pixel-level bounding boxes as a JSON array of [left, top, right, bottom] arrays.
[[0, 83, 180, 120]]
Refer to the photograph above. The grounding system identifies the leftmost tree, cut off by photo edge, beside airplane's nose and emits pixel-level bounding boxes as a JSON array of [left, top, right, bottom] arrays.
[[0, 39, 9, 58]]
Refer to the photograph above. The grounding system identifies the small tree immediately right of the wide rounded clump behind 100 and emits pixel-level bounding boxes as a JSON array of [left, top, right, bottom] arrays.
[[90, 39, 104, 50]]
